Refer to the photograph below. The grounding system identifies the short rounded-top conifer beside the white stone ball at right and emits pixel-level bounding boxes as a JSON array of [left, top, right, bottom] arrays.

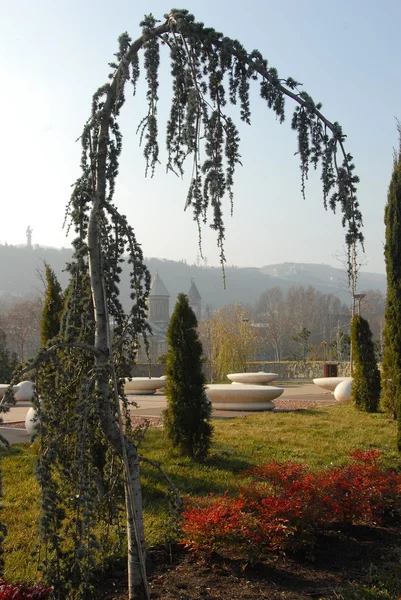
[[351, 315, 380, 412]]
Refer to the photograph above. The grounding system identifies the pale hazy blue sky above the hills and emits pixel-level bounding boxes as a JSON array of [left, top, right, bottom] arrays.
[[0, 0, 401, 272]]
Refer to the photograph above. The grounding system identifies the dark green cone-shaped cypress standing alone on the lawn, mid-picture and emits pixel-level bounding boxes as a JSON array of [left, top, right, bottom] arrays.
[[164, 294, 212, 458]]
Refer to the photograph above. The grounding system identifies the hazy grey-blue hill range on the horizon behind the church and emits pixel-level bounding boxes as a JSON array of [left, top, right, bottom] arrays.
[[0, 245, 386, 310]]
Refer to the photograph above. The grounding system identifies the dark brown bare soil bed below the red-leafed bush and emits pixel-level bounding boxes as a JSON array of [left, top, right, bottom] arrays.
[[100, 525, 401, 600]]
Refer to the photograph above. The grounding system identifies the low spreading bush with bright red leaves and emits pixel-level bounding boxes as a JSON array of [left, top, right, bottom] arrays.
[[182, 450, 401, 560]]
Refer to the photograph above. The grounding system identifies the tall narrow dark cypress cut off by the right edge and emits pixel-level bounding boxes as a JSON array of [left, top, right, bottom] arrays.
[[382, 124, 401, 451]]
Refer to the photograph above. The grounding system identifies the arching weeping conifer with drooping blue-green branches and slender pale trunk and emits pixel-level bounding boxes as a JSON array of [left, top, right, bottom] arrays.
[[3, 10, 363, 599]]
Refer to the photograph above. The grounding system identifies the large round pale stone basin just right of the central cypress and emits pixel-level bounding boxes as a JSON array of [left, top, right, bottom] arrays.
[[206, 383, 284, 411]]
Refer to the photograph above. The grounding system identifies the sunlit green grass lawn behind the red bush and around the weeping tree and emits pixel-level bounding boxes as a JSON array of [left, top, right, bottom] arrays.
[[1, 404, 401, 597]]
